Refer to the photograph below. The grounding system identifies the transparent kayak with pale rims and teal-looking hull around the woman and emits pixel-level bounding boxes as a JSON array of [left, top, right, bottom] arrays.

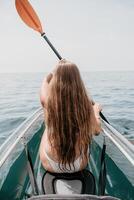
[[0, 109, 134, 200]]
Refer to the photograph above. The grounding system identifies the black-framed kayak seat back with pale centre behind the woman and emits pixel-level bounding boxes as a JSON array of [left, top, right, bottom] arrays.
[[42, 169, 95, 195]]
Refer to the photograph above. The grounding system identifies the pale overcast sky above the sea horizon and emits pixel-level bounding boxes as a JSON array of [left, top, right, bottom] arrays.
[[0, 0, 134, 72]]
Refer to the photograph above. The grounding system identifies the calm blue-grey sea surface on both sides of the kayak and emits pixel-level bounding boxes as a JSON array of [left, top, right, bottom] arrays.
[[0, 72, 134, 145]]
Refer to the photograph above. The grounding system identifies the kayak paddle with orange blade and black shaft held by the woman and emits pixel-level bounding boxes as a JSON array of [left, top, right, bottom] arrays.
[[15, 0, 109, 123]]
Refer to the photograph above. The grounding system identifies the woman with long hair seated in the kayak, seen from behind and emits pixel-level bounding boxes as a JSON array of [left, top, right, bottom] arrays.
[[40, 60, 101, 173]]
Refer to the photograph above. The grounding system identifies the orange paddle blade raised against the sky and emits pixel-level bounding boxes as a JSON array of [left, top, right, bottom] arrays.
[[15, 0, 43, 34]]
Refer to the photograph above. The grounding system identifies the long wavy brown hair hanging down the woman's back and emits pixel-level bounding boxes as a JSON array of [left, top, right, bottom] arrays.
[[46, 60, 94, 168]]
